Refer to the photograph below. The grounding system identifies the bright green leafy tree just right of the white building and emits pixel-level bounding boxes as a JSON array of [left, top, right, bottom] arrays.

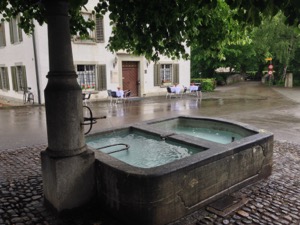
[[191, 0, 253, 77]]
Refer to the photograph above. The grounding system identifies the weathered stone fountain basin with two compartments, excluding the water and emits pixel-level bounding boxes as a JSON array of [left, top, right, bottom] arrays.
[[87, 117, 273, 225]]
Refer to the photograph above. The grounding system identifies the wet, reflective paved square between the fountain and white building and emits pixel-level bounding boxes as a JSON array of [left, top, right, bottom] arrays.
[[0, 82, 300, 149]]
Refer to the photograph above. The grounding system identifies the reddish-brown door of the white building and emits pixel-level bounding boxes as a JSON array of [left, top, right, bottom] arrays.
[[122, 61, 139, 96]]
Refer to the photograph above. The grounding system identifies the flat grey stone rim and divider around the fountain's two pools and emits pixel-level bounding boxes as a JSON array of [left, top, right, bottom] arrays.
[[88, 116, 273, 176]]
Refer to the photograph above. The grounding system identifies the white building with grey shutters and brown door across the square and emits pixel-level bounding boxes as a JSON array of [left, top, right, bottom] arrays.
[[0, 4, 190, 103]]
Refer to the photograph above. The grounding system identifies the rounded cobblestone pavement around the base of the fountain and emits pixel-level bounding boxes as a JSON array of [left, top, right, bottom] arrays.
[[0, 141, 300, 225]]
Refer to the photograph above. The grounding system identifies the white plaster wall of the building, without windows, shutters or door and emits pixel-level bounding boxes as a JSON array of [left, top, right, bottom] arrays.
[[0, 0, 190, 103]]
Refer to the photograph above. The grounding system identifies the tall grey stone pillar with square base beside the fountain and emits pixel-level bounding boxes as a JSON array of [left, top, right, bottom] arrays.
[[41, 0, 95, 212]]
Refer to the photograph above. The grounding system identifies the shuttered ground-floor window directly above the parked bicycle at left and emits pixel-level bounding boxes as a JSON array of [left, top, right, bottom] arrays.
[[11, 66, 27, 91]]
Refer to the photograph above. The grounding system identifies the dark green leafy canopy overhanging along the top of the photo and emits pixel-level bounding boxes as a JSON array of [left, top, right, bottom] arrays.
[[0, 0, 300, 60]]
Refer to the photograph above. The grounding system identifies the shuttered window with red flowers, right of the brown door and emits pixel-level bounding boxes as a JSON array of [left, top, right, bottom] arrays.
[[154, 64, 179, 86]]
